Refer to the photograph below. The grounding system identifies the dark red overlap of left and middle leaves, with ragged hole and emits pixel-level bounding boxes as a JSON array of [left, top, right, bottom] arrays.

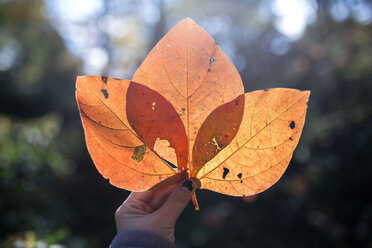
[[126, 82, 188, 170]]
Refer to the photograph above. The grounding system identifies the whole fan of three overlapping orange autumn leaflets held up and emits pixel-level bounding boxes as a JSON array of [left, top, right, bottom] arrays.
[[76, 18, 310, 207]]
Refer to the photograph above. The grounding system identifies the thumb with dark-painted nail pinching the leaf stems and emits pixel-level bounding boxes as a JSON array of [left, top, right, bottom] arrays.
[[157, 178, 200, 224]]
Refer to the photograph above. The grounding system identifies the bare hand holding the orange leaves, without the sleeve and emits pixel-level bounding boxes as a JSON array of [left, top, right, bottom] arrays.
[[115, 178, 200, 243]]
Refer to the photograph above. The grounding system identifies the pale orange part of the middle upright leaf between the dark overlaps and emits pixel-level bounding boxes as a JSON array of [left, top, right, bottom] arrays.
[[132, 18, 244, 176]]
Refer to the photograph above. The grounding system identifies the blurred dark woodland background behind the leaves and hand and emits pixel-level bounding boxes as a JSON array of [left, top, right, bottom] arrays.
[[0, 0, 372, 248]]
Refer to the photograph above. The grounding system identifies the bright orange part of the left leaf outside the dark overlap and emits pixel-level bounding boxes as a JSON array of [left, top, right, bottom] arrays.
[[76, 76, 176, 191]]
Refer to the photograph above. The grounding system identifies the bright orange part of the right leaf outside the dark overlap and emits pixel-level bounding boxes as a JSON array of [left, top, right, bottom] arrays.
[[196, 88, 310, 196]]
